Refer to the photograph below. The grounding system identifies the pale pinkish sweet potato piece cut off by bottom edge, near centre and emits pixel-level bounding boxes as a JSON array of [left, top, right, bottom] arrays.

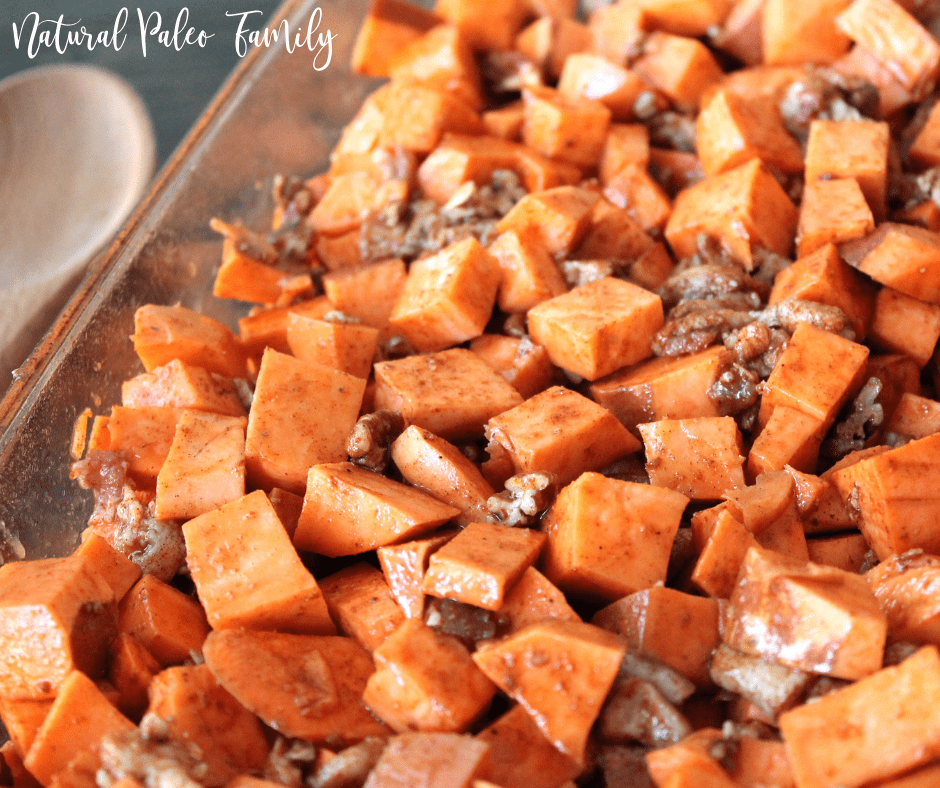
[[363, 733, 488, 788]]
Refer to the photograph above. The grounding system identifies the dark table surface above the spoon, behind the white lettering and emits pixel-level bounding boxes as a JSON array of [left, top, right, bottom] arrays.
[[0, 0, 279, 167]]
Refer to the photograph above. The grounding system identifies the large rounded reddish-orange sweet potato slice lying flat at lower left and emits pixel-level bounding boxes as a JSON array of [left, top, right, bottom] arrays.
[[204, 629, 390, 746]]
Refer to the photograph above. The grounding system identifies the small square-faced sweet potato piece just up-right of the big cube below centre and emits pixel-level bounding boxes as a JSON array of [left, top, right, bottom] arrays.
[[637, 416, 744, 501]]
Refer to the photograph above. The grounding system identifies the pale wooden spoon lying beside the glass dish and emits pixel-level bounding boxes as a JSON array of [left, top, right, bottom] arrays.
[[0, 65, 156, 378]]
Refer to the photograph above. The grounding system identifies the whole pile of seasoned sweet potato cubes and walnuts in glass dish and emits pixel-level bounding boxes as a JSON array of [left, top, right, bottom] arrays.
[[0, 0, 940, 788]]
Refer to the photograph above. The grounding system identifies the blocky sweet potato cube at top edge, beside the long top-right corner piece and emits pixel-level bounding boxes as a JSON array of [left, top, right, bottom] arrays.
[[762, 0, 851, 65]]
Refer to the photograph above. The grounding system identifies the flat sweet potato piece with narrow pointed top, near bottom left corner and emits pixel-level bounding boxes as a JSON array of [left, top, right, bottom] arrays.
[[23, 670, 134, 785]]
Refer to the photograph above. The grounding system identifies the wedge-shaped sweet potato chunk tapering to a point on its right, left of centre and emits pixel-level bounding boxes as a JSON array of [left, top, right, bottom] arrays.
[[294, 462, 460, 558]]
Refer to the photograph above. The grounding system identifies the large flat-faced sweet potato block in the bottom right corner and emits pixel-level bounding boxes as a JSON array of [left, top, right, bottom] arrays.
[[780, 648, 940, 788]]
